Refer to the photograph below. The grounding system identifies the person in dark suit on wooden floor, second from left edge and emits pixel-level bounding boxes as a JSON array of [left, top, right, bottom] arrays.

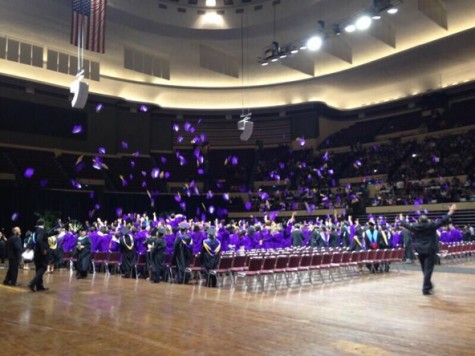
[[28, 219, 49, 292]]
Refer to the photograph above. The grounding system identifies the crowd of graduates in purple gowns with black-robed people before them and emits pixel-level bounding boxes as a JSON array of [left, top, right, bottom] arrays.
[[2, 209, 475, 286]]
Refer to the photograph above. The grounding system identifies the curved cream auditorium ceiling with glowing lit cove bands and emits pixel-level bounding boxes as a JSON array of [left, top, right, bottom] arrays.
[[0, 0, 475, 109]]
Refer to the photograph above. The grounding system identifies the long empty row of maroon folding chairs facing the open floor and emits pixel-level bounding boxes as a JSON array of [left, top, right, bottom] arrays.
[[206, 249, 404, 289]]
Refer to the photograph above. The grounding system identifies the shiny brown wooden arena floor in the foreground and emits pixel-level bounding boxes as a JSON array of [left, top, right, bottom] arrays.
[[0, 262, 475, 356]]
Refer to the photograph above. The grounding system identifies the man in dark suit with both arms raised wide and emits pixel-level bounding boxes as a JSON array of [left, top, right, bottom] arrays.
[[399, 204, 457, 295]]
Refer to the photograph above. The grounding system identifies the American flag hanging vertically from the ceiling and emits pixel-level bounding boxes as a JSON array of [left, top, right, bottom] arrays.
[[71, 0, 107, 53]]
